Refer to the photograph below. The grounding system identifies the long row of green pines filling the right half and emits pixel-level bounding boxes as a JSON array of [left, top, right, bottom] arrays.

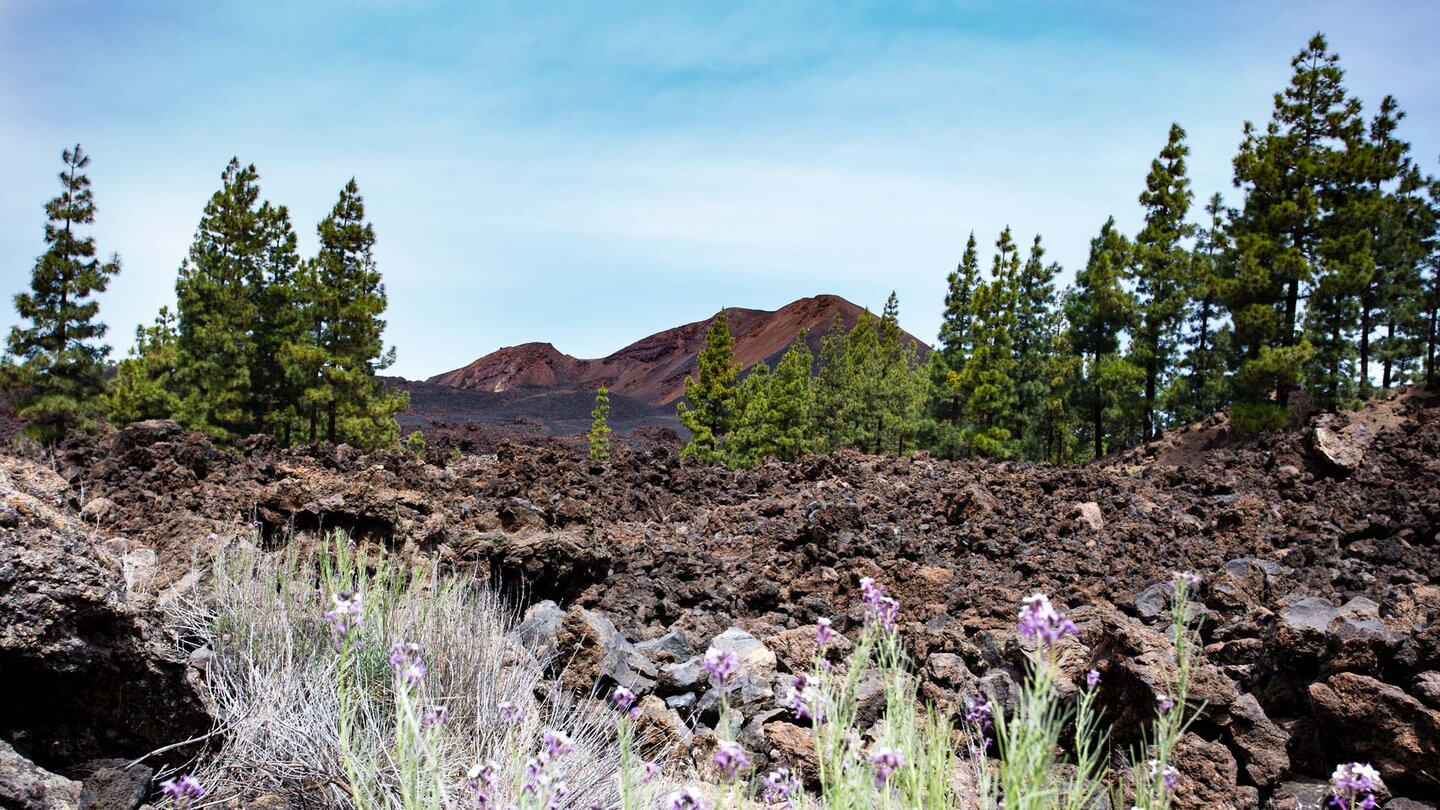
[[680, 35, 1440, 466]]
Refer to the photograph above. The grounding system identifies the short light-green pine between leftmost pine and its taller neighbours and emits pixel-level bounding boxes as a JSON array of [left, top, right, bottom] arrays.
[[107, 307, 180, 425]]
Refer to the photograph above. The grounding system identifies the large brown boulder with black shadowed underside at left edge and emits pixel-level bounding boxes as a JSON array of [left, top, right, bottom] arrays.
[[0, 458, 210, 768]]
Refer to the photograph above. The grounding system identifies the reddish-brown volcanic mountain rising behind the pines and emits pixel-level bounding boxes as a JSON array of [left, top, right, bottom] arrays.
[[428, 295, 929, 405]]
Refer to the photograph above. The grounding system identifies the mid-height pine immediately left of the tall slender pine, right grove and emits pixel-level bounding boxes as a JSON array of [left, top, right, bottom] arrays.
[[1064, 218, 1136, 458]]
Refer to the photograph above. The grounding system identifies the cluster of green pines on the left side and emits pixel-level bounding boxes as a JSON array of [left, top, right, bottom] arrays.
[[0, 146, 408, 448]]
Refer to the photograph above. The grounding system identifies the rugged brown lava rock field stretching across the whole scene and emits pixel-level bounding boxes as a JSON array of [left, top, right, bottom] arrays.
[[0, 391, 1440, 809]]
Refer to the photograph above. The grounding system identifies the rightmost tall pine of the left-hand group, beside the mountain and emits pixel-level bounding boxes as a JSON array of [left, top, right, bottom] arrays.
[[299, 179, 409, 448]]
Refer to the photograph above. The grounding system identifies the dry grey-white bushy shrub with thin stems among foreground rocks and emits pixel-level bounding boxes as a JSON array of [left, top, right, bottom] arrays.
[[161, 533, 662, 810]]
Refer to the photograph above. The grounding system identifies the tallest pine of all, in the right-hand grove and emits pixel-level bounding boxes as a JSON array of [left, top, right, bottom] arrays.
[[1223, 35, 1359, 417]]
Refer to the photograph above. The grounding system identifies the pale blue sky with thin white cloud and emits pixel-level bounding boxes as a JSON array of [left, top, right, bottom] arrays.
[[0, 0, 1440, 379]]
